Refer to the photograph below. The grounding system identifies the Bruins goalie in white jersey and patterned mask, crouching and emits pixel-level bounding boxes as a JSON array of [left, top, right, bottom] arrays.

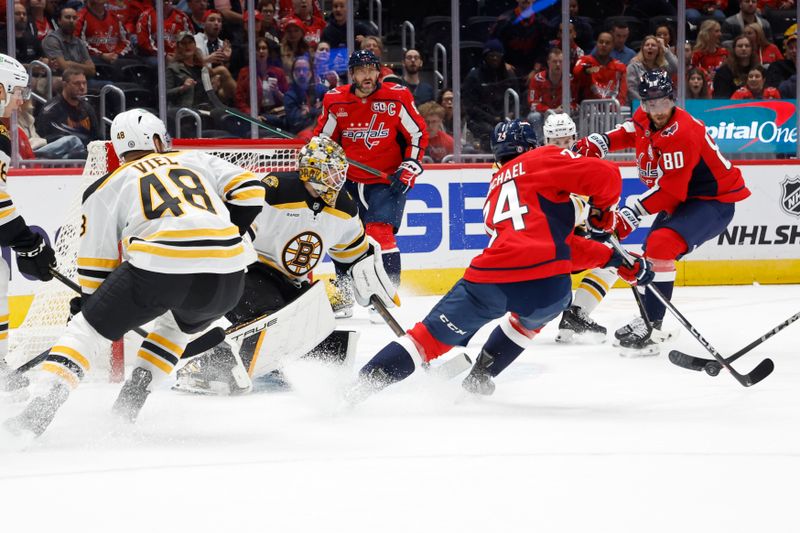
[[176, 136, 397, 394]]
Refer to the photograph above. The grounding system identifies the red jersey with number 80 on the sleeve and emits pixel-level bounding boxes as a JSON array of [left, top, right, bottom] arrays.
[[608, 107, 750, 213]]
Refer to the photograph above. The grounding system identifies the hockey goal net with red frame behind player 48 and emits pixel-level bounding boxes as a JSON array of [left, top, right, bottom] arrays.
[[9, 139, 303, 381]]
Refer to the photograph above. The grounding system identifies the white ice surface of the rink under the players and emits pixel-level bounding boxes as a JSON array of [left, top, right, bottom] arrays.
[[0, 286, 800, 533]]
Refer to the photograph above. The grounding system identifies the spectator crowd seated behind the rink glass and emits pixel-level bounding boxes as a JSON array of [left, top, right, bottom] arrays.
[[0, 0, 797, 161]]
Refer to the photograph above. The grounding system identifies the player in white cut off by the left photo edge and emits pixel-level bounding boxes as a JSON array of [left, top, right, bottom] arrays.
[[0, 54, 56, 392]]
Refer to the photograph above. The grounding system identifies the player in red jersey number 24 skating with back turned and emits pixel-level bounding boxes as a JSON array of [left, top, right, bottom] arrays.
[[348, 120, 648, 401]]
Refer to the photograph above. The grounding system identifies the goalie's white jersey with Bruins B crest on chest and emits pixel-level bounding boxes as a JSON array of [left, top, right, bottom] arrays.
[[253, 172, 369, 282]]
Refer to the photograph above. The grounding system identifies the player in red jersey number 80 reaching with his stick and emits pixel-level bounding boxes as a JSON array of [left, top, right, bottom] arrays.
[[575, 70, 750, 356]]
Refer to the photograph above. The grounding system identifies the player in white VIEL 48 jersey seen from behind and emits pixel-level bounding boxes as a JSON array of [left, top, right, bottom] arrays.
[[4, 109, 264, 435]]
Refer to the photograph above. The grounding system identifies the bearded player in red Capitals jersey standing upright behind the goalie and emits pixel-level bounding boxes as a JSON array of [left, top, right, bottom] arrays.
[[314, 50, 428, 314]]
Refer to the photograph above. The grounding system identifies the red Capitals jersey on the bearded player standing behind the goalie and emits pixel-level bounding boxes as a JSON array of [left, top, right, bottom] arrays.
[[314, 83, 428, 183]]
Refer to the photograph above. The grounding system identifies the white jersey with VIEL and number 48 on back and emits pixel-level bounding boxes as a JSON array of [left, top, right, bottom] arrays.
[[78, 151, 264, 294]]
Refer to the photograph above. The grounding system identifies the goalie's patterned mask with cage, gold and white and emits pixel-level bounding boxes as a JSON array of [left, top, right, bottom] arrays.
[[297, 135, 349, 207]]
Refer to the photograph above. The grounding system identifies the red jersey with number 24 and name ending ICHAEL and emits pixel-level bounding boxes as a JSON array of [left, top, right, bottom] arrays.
[[464, 145, 622, 283]]
